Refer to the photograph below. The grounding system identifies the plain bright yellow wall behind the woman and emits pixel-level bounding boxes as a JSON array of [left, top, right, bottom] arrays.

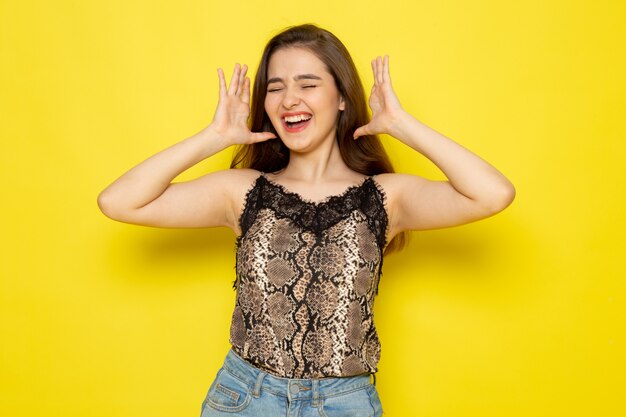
[[0, 0, 626, 417]]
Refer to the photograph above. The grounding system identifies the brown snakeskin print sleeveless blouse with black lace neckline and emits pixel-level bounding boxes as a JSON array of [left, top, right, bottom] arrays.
[[230, 174, 388, 378]]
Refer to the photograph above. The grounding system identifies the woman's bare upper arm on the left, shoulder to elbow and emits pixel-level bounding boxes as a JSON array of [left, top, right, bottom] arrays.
[[101, 169, 254, 232]]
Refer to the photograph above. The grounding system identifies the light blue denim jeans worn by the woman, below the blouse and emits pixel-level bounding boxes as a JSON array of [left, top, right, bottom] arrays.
[[201, 350, 383, 417]]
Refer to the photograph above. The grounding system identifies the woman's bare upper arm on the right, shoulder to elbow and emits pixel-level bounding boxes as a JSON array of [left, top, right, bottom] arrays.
[[379, 174, 510, 236]]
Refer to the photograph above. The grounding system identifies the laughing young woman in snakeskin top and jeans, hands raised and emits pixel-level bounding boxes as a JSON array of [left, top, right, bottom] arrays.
[[98, 25, 515, 417]]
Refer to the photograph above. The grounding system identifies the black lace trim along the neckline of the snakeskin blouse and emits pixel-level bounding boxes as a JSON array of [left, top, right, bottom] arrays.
[[238, 174, 388, 251]]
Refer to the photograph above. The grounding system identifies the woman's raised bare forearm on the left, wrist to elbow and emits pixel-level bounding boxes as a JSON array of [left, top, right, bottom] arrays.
[[98, 127, 228, 214]]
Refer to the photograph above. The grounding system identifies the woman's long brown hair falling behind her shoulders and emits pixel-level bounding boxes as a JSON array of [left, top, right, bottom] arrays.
[[231, 24, 406, 254]]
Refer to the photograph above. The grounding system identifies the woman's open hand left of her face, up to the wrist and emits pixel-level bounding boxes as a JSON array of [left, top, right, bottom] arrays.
[[207, 64, 276, 145]]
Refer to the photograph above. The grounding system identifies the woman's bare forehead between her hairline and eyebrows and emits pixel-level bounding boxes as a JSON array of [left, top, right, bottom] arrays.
[[267, 47, 331, 79]]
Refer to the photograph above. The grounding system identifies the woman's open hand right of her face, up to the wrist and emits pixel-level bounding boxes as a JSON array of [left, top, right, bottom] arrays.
[[354, 55, 406, 139]]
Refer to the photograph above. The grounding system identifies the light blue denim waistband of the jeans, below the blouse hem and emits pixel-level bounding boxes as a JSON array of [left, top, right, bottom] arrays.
[[223, 349, 376, 402]]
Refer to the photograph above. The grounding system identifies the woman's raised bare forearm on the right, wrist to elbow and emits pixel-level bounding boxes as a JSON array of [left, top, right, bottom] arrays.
[[392, 113, 515, 210]]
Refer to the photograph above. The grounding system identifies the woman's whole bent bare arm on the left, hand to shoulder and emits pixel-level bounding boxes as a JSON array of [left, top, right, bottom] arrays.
[[98, 65, 276, 229]]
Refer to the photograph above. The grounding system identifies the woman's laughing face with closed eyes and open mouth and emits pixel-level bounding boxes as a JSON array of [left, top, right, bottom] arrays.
[[265, 47, 345, 153]]
